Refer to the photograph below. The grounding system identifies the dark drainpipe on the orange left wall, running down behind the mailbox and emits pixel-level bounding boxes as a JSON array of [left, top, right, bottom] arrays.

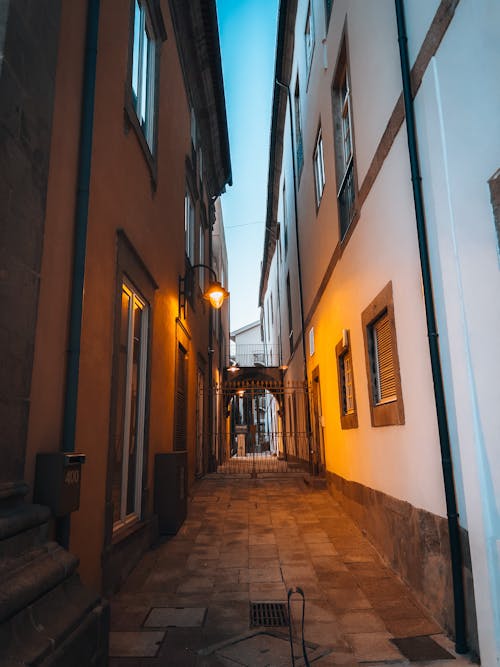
[[56, 0, 100, 548]]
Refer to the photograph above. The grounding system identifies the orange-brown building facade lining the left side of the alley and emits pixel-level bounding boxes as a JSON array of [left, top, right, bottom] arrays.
[[0, 0, 231, 664]]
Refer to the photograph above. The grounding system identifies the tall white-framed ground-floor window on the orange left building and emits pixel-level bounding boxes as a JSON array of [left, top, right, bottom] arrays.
[[112, 280, 149, 530]]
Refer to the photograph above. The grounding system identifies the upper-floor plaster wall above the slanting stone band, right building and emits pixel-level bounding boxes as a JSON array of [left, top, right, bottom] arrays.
[[292, 0, 401, 314]]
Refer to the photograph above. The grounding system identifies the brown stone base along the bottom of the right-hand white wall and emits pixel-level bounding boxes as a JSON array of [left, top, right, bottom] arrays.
[[327, 472, 478, 653]]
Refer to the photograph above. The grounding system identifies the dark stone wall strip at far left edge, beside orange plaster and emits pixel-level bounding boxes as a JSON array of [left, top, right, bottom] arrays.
[[0, 0, 60, 485]]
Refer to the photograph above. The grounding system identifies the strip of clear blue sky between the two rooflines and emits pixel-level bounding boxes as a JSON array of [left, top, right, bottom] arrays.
[[217, 0, 278, 330]]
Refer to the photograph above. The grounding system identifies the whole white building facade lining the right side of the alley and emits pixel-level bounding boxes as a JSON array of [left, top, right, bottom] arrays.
[[260, 0, 500, 665]]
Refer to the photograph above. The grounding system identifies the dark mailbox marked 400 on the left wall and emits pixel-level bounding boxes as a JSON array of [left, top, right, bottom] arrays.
[[33, 452, 85, 517]]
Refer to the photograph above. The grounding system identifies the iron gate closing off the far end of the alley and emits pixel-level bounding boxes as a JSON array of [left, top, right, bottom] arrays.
[[211, 380, 311, 476]]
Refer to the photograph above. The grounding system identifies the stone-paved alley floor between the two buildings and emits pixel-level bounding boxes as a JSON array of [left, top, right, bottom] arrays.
[[110, 475, 471, 667]]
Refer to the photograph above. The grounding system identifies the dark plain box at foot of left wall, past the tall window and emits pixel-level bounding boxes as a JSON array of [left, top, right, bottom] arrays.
[[154, 451, 187, 535]]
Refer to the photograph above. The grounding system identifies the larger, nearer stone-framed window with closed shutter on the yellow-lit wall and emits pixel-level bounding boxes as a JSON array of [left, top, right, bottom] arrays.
[[362, 283, 404, 426]]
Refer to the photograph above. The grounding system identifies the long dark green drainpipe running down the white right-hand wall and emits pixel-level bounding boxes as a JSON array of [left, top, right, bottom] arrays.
[[395, 0, 467, 653]]
